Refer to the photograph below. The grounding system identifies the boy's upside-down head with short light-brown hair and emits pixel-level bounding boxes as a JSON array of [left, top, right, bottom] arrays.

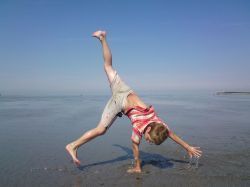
[[147, 122, 169, 145]]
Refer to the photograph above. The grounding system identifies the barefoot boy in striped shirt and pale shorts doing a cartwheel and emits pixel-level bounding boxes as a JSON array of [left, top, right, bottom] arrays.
[[66, 31, 202, 173]]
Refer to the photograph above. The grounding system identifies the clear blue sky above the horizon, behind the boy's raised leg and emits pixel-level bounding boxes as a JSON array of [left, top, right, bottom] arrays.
[[0, 0, 250, 94]]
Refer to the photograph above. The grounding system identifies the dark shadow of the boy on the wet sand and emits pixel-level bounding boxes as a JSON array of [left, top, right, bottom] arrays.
[[78, 144, 188, 170]]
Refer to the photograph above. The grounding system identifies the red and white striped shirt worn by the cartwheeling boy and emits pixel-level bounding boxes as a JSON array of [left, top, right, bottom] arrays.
[[126, 106, 169, 143]]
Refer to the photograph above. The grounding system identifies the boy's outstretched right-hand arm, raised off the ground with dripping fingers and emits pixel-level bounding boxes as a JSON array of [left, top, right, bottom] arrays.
[[169, 132, 202, 157]]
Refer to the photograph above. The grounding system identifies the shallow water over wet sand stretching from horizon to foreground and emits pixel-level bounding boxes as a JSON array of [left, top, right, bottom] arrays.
[[0, 92, 250, 186]]
